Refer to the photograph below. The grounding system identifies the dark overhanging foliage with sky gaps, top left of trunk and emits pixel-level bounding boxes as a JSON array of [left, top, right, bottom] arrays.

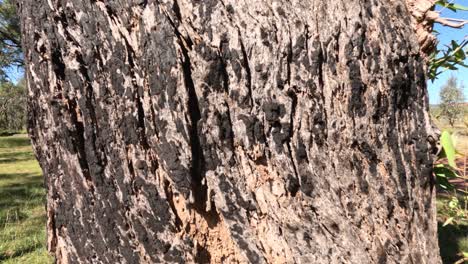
[[0, 0, 23, 81]]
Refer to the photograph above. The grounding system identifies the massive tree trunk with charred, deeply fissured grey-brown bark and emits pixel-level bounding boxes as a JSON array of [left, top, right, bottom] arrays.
[[19, 0, 440, 264]]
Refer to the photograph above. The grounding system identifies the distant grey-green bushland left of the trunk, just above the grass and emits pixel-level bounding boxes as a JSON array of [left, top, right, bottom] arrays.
[[0, 81, 27, 131]]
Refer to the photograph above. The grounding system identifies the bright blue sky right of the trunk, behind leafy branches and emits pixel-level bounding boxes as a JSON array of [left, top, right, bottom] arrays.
[[427, 0, 468, 104]]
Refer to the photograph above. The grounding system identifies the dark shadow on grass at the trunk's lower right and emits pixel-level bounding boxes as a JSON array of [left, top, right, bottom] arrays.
[[438, 223, 468, 264]]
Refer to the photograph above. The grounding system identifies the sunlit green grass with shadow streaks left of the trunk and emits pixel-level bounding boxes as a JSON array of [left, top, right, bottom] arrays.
[[0, 135, 52, 264]]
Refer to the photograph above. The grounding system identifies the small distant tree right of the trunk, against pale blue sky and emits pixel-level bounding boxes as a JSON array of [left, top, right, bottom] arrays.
[[440, 76, 465, 127]]
